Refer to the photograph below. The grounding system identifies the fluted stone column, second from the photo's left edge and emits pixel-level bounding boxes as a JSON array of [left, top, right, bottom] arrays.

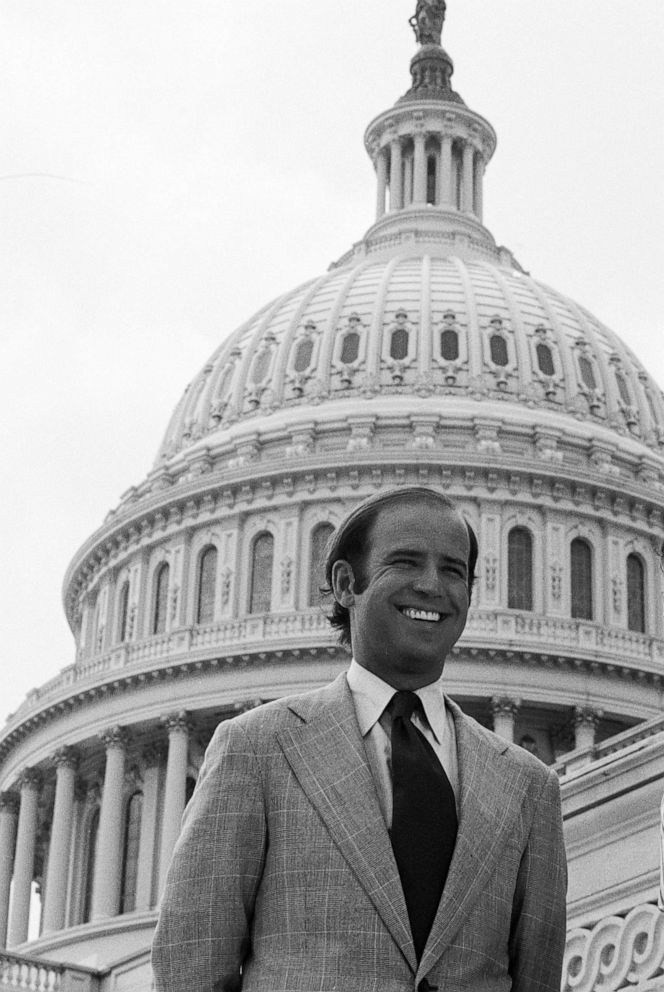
[[7, 768, 41, 947]]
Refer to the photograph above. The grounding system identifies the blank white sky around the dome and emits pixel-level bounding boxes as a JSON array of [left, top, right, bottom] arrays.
[[0, 0, 664, 719]]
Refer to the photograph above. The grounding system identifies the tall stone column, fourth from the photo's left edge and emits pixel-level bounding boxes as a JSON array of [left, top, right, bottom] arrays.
[[92, 727, 127, 920]]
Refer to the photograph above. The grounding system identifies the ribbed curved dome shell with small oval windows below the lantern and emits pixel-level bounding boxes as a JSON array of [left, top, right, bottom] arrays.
[[157, 248, 664, 471]]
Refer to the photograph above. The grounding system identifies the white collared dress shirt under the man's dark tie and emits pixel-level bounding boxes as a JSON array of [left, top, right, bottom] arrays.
[[346, 659, 459, 830]]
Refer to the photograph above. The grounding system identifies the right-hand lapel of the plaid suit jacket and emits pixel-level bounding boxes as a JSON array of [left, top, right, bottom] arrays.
[[420, 704, 518, 973]]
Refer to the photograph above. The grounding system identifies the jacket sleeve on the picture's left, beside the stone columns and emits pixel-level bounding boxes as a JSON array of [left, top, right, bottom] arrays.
[[152, 720, 267, 992]]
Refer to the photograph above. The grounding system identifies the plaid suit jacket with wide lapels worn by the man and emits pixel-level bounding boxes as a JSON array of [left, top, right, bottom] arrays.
[[153, 675, 566, 992]]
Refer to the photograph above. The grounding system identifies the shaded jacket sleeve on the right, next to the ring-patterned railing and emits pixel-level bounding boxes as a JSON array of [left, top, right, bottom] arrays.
[[510, 770, 567, 992]]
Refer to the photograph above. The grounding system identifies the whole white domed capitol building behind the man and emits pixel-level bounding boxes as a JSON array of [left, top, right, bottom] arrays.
[[0, 7, 664, 992]]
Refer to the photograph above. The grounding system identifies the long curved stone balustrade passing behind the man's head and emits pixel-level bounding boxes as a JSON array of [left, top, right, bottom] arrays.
[[8, 609, 664, 725]]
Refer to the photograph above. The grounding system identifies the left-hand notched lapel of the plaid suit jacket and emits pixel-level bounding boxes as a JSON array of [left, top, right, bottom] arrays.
[[277, 674, 416, 971]]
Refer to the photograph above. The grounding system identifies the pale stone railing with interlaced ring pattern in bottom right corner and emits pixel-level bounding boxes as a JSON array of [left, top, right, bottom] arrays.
[[562, 903, 664, 992]]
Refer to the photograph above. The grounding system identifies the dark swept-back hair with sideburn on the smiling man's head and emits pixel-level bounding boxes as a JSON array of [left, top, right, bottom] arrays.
[[321, 486, 477, 644]]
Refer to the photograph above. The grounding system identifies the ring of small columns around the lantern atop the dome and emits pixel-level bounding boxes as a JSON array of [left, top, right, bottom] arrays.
[[375, 132, 486, 221]]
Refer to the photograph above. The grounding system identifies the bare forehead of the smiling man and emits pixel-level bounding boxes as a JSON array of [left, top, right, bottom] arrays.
[[368, 499, 470, 558]]
